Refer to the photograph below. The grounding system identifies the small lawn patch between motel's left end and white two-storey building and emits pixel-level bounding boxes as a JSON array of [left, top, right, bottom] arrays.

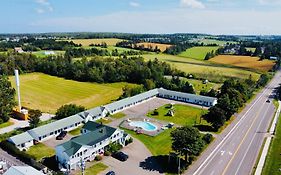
[[27, 143, 55, 161]]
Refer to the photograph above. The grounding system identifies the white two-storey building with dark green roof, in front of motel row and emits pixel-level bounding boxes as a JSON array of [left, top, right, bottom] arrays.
[[56, 121, 129, 169]]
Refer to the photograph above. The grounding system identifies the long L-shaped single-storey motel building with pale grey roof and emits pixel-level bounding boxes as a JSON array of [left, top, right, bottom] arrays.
[[8, 88, 217, 150]]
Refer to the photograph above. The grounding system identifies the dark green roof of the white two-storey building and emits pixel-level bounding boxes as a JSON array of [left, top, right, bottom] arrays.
[[58, 121, 116, 156]]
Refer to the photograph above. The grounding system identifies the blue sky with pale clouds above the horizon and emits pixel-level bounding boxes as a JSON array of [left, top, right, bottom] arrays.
[[0, 0, 281, 35]]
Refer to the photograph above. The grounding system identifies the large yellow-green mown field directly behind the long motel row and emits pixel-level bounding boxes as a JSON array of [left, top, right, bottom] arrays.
[[10, 73, 136, 113]]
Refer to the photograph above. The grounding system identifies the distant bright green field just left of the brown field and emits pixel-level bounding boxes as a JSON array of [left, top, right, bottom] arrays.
[[179, 46, 219, 60]]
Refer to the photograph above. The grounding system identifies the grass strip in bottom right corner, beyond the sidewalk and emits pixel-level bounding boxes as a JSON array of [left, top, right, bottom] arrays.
[[262, 113, 281, 175]]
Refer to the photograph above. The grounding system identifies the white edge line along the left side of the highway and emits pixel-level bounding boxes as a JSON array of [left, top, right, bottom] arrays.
[[191, 73, 275, 175]]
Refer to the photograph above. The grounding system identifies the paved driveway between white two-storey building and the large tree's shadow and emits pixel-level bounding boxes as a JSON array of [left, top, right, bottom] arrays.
[[100, 139, 162, 175]]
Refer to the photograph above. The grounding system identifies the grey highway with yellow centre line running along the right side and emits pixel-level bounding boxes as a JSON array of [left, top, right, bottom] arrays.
[[186, 71, 281, 175]]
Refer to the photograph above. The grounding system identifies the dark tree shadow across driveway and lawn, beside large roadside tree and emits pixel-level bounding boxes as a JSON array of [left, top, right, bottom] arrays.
[[140, 155, 187, 174]]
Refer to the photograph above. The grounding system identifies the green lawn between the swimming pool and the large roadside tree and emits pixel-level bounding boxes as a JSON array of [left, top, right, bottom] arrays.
[[122, 128, 173, 156]]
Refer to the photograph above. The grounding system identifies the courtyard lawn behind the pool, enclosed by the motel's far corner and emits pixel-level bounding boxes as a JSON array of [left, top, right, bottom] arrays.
[[147, 104, 208, 126]]
